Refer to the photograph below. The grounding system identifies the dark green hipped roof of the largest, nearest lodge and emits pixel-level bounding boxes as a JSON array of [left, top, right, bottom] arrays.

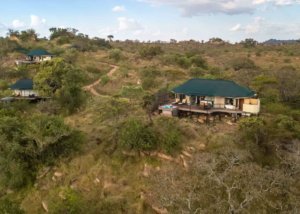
[[172, 79, 255, 97]]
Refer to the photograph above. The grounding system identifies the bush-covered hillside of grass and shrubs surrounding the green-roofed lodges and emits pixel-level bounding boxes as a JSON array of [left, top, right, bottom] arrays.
[[0, 28, 300, 214]]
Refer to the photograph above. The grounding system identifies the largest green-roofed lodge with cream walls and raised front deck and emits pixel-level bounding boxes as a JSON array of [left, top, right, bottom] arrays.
[[159, 79, 260, 115]]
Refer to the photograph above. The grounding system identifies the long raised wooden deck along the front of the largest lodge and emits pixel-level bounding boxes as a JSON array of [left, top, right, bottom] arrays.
[[159, 104, 245, 114]]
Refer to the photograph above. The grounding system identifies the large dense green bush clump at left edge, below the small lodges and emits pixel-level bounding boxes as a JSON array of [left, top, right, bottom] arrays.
[[0, 110, 82, 188]]
